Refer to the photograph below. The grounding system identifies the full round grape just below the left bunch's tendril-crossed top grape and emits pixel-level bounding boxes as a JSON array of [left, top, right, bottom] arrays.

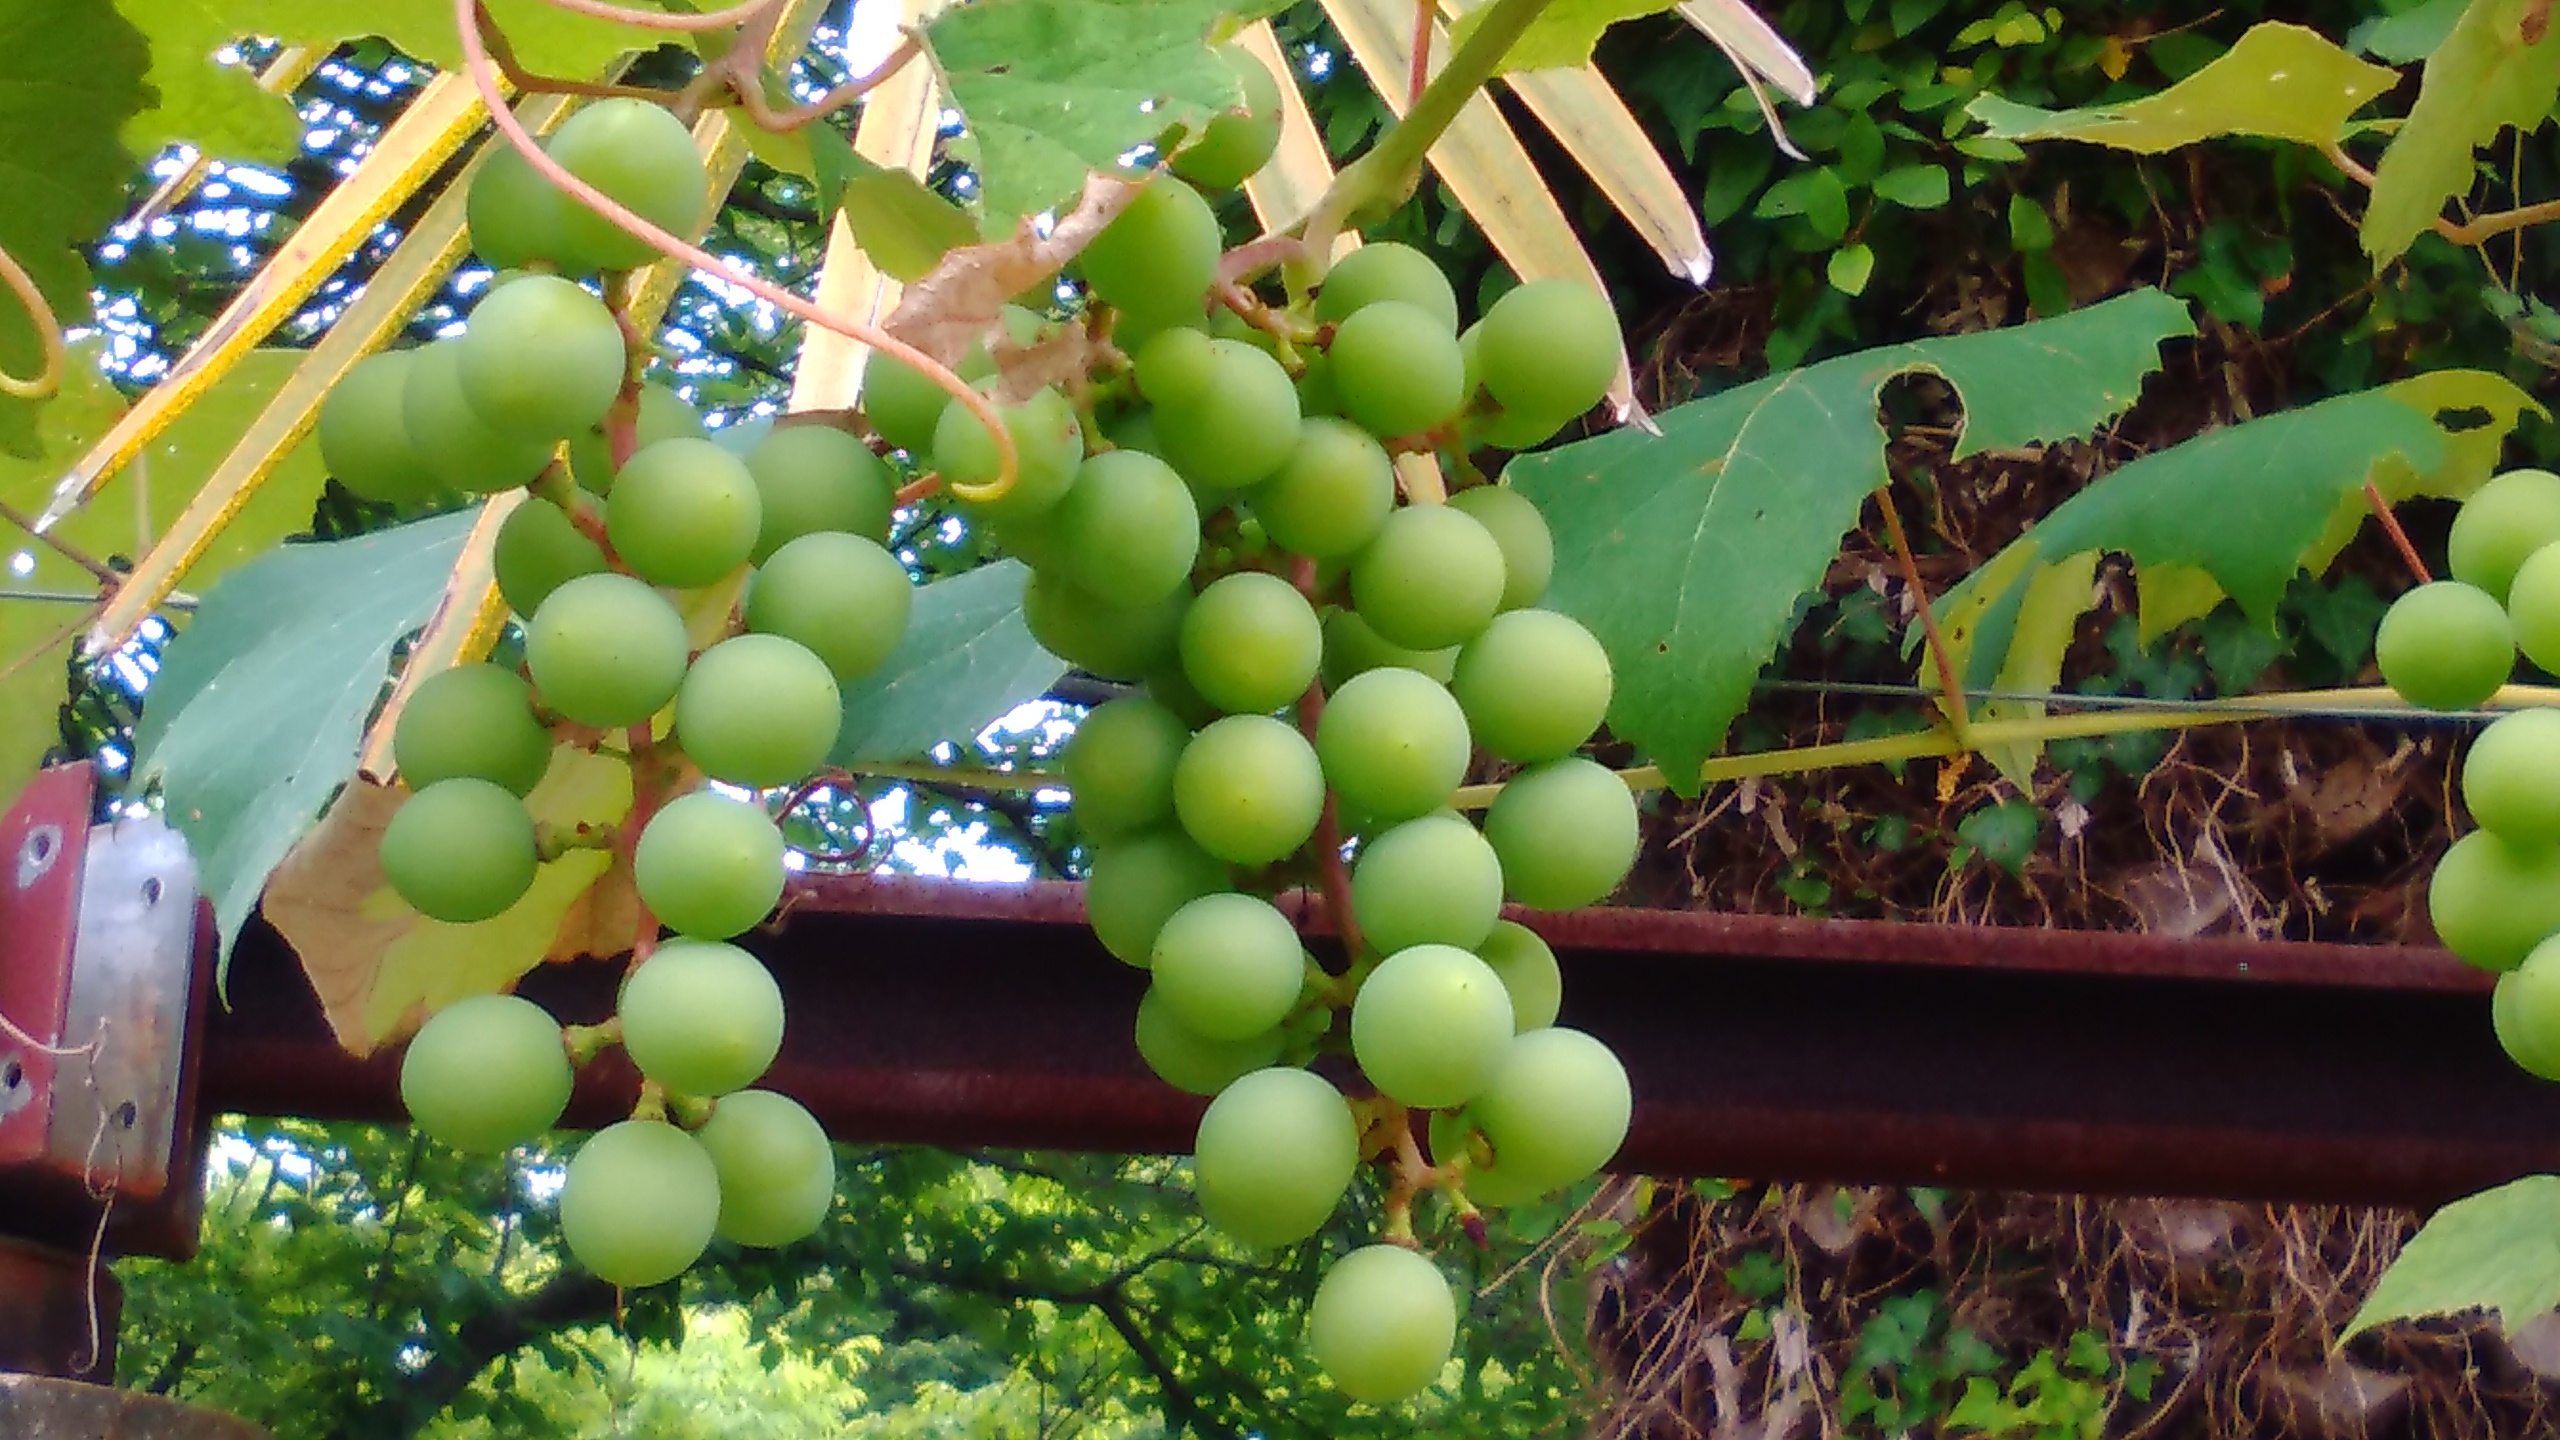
[[461, 274, 627, 443]]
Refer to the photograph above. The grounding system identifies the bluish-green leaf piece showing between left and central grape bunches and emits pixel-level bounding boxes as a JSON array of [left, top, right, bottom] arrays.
[[829, 561, 1068, 766]]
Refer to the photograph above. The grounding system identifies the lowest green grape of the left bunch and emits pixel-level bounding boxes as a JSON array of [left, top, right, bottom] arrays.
[[561, 1120, 719, 1289]]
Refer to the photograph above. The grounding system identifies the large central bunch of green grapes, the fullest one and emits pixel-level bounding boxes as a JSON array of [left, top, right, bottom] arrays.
[[865, 54, 1638, 1402]]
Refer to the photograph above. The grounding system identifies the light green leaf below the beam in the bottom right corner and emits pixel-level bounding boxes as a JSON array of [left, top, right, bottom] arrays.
[[2337, 1176, 2560, 1343]]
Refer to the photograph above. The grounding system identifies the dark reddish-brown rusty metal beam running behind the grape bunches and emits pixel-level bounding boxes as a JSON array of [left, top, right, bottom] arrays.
[[205, 876, 2560, 1204]]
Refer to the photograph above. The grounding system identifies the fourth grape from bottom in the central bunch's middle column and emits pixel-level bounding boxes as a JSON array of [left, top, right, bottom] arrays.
[[1316, 669, 1472, 825]]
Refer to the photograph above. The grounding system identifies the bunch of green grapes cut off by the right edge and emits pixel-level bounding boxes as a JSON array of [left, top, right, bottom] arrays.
[[2373, 469, 2560, 1079]]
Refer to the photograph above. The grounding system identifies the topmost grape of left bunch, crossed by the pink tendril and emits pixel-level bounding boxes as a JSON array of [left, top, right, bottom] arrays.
[[545, 97, 709, 269]]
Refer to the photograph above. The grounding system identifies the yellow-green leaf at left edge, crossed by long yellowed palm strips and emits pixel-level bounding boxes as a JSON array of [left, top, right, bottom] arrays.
[[0, 341, 328, 805]]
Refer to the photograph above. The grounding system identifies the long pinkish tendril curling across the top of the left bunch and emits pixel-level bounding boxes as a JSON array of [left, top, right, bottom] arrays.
[[453, 0, 1024, 500]]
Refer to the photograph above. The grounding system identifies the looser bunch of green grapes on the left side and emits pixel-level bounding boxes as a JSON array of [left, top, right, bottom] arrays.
[[350, 100, 911, 1286]]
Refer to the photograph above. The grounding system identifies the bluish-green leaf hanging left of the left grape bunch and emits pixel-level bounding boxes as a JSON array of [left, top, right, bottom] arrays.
[[133, 510, 476, 961]]
